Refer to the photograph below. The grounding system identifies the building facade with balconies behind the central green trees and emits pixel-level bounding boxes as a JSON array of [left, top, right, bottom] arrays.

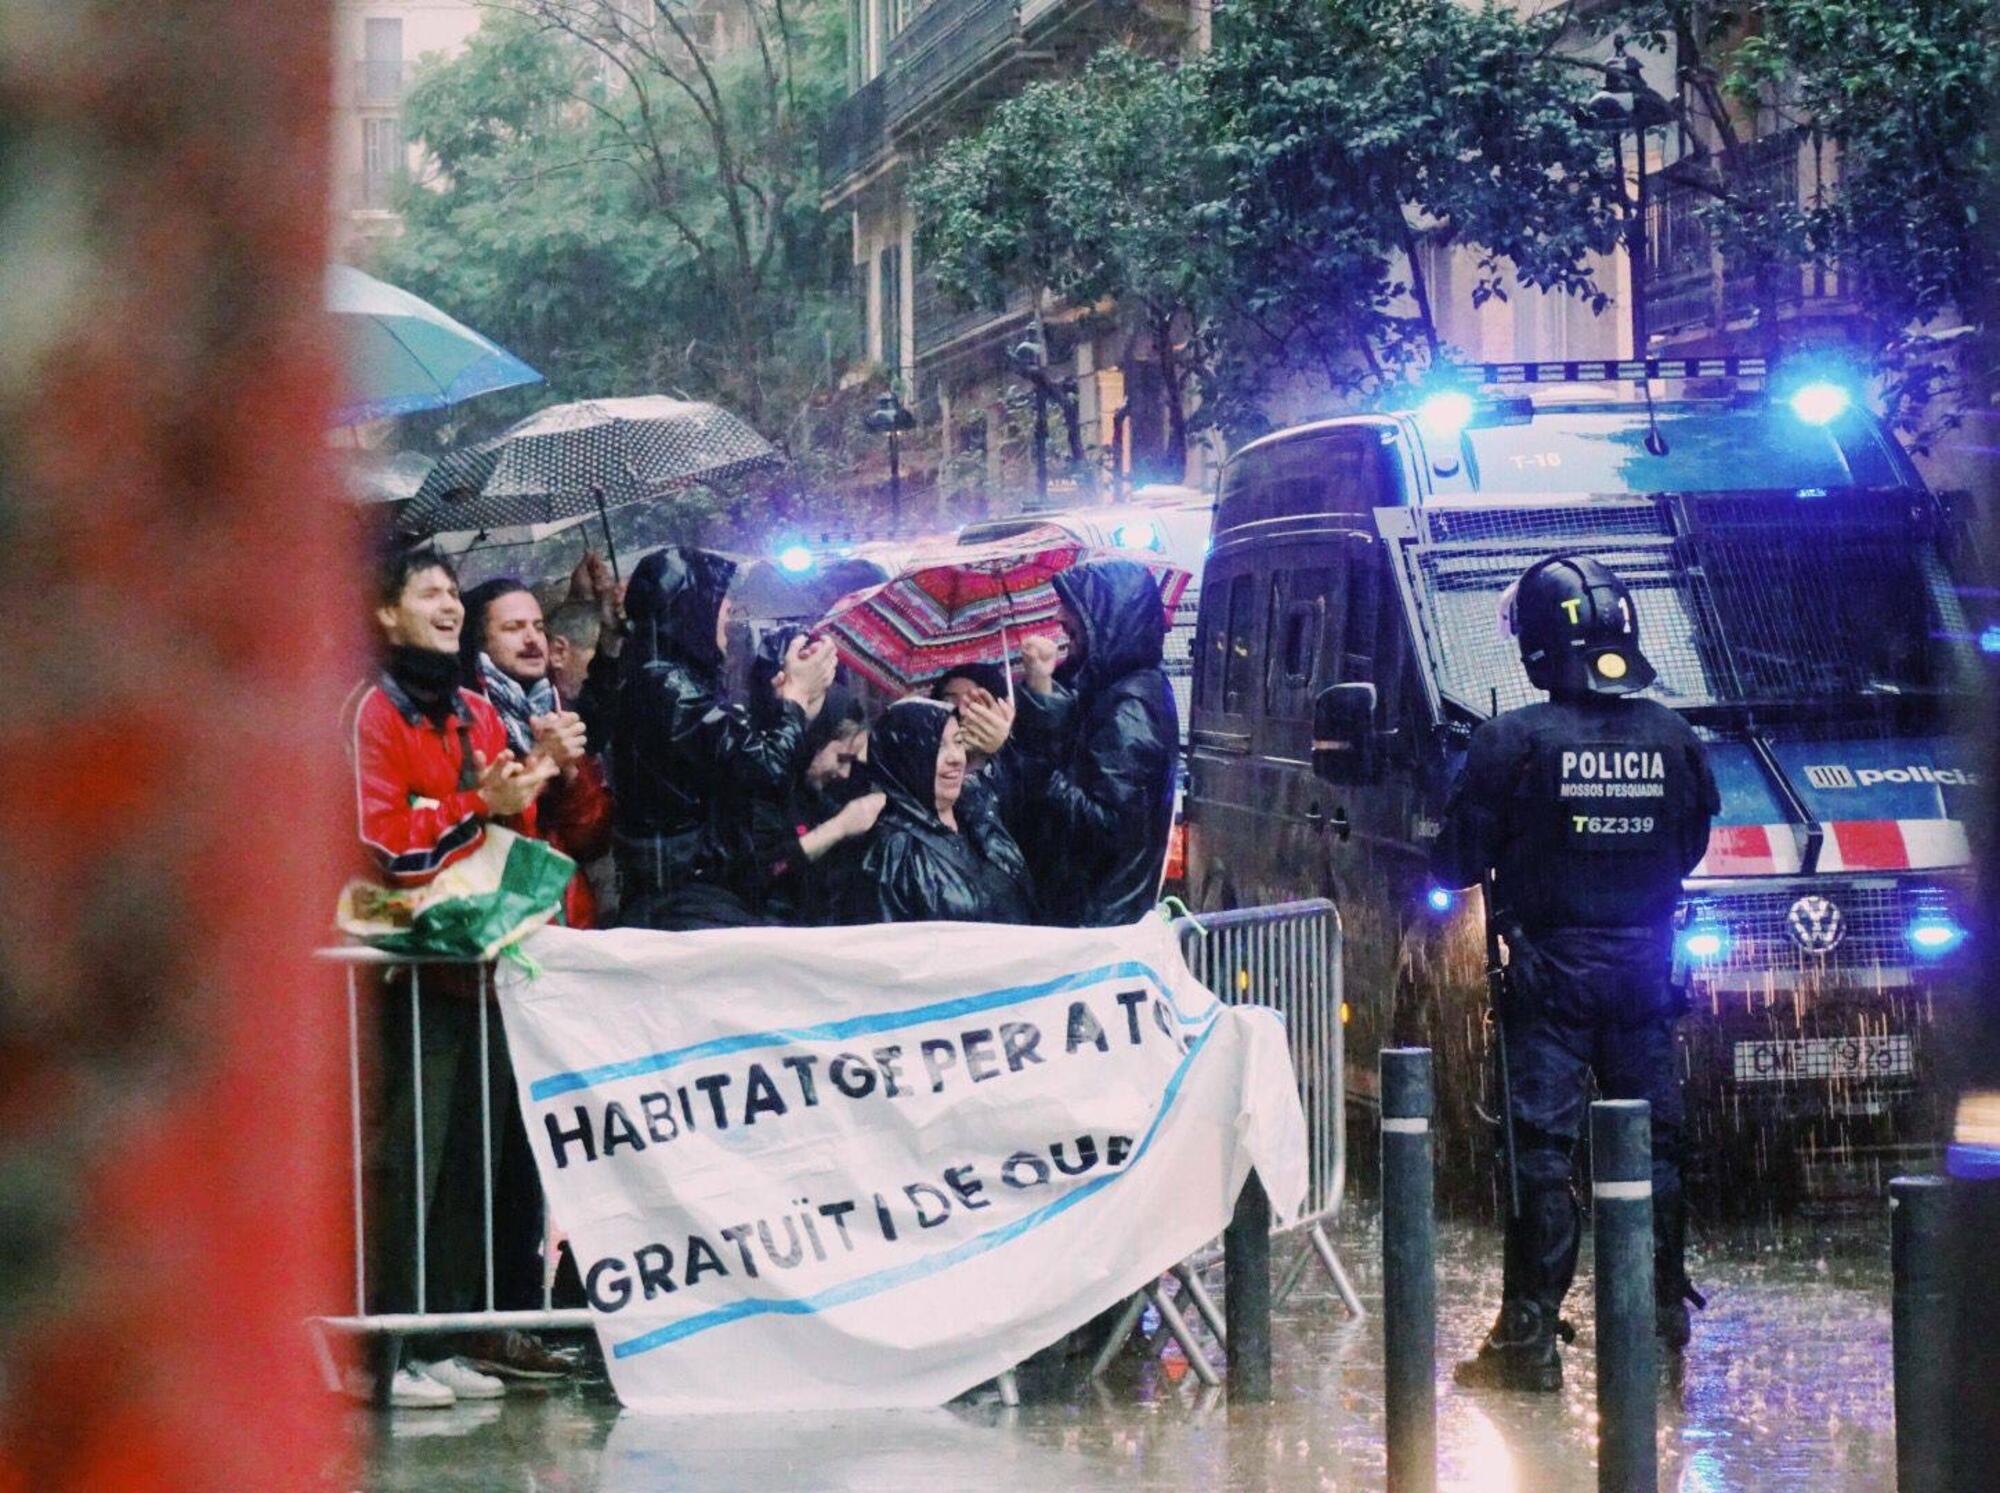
[[822, 0, 1632, 518]]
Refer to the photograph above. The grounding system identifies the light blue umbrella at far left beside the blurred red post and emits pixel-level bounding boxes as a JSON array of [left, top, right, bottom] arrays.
[[326, 264, 542, 424]]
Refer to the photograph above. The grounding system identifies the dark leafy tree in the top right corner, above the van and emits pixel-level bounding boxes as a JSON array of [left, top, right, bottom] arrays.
[[1598, 0, 2000, 438]]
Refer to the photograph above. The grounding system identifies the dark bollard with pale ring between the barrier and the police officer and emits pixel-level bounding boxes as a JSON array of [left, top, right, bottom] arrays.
[[1382, 1047, 1438, 1493]]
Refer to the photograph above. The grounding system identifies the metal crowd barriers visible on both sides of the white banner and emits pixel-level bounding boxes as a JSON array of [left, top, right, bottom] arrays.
[[312, 899, 1362, 1389]]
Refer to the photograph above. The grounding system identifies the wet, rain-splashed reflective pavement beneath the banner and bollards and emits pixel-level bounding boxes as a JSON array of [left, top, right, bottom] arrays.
[[340, 1221, 1896, 1493]]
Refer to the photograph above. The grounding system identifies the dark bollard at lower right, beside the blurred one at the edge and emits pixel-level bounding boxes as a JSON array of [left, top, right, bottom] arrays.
[[1888, 1177, 1952, 1493]]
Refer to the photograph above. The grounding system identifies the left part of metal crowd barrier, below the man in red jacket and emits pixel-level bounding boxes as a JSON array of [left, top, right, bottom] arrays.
[[310, 947, 590, 1385]]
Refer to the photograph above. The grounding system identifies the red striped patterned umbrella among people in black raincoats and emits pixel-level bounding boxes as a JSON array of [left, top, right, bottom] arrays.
[[824, 526, 1192, 694]]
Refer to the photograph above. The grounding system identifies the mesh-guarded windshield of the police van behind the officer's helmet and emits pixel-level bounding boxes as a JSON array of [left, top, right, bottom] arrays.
[[1380, 492, 1970, 714]]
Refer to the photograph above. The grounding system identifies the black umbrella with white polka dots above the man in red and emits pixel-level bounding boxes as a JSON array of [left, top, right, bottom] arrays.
[[398, 394, 784, 568]]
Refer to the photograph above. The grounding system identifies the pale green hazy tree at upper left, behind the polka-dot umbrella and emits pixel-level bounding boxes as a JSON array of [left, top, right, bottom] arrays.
[[382, 0, 854, 444]]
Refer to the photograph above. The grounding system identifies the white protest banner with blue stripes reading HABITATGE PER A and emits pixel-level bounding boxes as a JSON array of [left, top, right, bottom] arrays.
[[500, 919, 1306, 1411]]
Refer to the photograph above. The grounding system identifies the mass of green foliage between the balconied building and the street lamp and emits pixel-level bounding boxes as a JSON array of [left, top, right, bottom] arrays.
[[914, 0, 1620, 442]]
